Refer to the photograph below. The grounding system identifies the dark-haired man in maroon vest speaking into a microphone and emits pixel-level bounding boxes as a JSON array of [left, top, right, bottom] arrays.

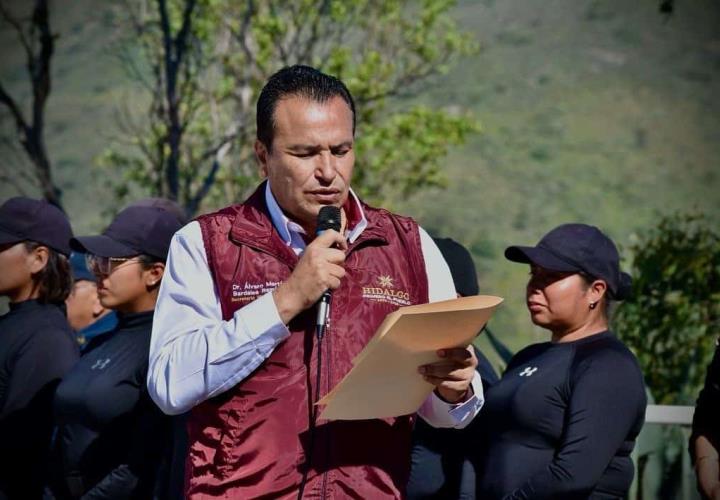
[[148, 66, 482, 499]]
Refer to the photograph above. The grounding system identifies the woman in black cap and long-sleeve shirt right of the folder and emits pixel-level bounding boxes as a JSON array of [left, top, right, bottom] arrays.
[[478, 224, 646, 499]]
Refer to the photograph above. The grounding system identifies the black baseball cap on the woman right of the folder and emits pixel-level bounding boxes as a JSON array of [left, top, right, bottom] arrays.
[[505, 224, 632, 300]]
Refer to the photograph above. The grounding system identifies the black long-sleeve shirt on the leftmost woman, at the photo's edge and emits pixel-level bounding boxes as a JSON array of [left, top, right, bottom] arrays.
[[0, 300, 79, 499]]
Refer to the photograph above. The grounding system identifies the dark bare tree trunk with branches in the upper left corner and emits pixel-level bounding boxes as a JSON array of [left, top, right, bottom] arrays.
[[0, 0, 62, 208]]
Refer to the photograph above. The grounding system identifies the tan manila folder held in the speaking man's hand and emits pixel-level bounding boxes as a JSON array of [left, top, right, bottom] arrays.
[[317, 295, 503, 420]]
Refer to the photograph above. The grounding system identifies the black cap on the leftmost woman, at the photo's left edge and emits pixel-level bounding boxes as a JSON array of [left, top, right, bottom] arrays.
[[0, 196, 73, 256]]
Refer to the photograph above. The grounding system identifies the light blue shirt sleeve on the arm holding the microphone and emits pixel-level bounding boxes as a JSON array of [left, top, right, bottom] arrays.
[[147, 222, 290, 415]]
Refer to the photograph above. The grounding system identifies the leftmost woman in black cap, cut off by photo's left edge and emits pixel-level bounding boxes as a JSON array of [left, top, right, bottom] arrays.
[[0, 197, 78, 499]]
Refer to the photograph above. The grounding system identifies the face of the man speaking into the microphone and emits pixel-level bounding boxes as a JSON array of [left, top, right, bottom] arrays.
[[255, 96, 355, 234]]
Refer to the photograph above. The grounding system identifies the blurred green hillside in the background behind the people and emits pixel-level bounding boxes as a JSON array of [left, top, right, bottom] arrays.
[[0, 0, 720, 360]]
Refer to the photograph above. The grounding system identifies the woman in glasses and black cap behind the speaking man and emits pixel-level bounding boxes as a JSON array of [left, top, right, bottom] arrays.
[[51, 207, 180, 498]]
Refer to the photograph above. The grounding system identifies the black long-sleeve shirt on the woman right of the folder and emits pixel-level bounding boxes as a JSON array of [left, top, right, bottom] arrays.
[[478, 332, 646, 500]]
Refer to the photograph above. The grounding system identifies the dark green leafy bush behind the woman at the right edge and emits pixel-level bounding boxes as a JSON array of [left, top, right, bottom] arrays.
[[614, 214, 720, 404]]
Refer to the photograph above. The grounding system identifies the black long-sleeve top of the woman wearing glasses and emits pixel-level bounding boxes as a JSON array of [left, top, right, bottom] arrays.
[[53, 311, 170, 498]]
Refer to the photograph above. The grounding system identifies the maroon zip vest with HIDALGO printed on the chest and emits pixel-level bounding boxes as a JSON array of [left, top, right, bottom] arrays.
[[186, 184, 428, 499]]
